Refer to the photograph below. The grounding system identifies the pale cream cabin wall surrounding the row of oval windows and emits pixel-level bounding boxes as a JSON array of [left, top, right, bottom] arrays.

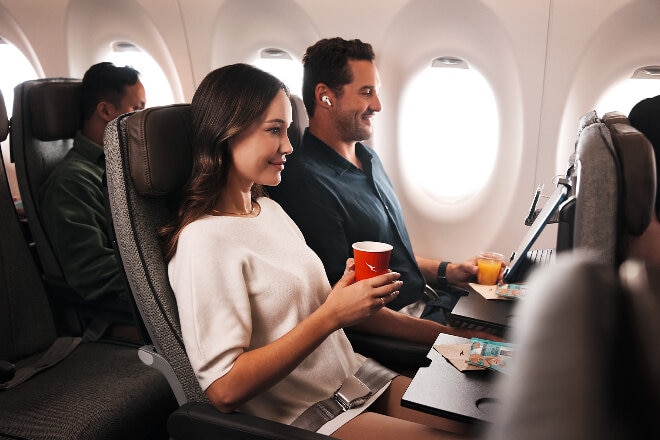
[[0, 0, 660, 260]]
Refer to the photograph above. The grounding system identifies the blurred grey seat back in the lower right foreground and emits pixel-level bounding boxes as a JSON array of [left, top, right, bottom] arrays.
[[484, 252, 660, 440]]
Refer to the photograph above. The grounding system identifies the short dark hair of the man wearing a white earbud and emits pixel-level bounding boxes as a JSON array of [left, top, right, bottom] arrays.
[[302, 37, 376, 116]]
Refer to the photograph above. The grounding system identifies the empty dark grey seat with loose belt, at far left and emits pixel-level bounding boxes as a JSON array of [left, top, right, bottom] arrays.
[[0, 90, 176, 440]]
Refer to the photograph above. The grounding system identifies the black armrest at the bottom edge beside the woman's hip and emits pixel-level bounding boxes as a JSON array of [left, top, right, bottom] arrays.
[[167, 402, 331, 440]]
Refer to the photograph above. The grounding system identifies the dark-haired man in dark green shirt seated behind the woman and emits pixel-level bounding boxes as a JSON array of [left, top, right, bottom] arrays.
[[38, 62, 145, 336]]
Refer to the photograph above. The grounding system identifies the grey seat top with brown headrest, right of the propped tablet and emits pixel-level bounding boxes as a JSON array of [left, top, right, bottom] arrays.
[[573, 112, 657, 264]]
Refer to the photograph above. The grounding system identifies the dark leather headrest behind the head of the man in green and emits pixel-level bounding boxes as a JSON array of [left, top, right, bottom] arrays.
[[28, 79, 82, 142]]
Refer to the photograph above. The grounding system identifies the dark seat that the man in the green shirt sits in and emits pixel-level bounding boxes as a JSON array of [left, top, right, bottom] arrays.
[[10, 78, 135, 334]]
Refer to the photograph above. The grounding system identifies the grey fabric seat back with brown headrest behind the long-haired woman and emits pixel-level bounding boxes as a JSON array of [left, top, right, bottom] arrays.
[[104, 104, 207, 404]]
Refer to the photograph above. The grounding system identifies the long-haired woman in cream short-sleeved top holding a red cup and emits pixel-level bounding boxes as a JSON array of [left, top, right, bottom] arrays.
[[160, 64, 474, 440]]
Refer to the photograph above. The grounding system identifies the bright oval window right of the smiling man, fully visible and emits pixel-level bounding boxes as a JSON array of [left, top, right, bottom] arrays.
[[399, 57, 499, 204]]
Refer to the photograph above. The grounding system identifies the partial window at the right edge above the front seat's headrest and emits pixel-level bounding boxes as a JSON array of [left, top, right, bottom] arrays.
[[595, 66, 660, 115]]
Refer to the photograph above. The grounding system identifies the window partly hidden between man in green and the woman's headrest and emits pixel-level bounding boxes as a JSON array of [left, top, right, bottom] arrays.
[[108, 42, 174, 107]]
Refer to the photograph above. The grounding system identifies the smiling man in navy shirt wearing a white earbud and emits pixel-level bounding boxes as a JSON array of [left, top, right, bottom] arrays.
[[269, 38, 501, 326]]
